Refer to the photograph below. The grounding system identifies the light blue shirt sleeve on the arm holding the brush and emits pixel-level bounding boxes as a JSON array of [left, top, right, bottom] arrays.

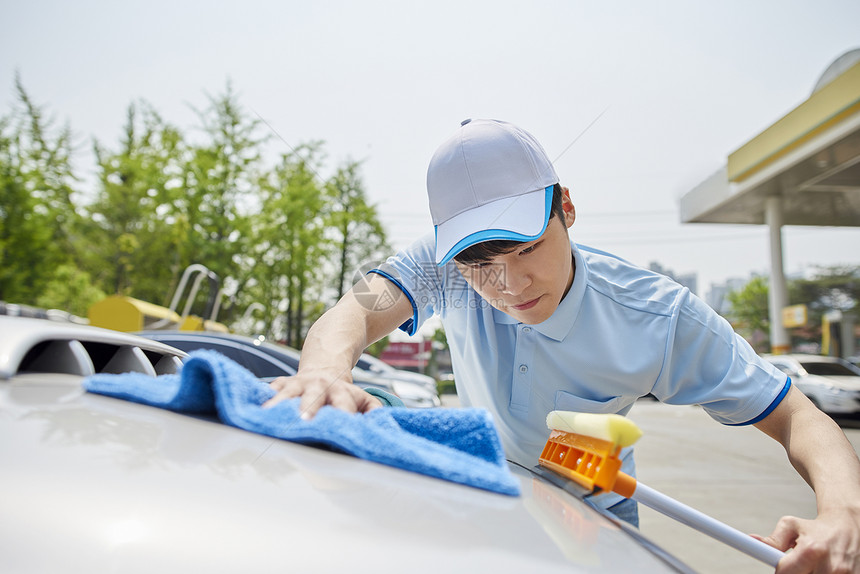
[[652, 289, 790, 425]]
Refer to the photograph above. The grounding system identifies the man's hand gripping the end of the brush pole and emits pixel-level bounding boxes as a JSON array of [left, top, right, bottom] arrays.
[[756, 507, 860, 574]]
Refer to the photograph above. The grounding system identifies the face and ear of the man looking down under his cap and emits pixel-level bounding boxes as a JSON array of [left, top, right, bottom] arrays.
[[455, 190, 575, 325]]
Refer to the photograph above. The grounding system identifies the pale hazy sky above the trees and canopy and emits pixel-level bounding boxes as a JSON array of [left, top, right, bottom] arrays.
[[0, 0, 860, 304]]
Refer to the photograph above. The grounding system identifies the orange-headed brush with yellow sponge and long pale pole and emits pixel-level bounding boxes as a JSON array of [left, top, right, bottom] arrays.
[[539, 411, 785, 568]]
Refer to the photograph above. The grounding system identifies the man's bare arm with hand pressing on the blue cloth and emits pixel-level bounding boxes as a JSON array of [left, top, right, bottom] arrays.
[[263, 274, 412, 419]]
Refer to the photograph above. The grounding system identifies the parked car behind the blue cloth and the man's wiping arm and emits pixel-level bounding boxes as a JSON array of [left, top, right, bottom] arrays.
[[139, 331, 441, 408]]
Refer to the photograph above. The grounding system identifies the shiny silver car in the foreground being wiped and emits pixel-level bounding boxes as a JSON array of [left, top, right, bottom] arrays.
[[0, 317, 690, 574]]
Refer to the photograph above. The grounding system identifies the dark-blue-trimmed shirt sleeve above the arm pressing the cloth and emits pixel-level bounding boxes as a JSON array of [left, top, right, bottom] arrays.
[[369, 233, 443, 335]]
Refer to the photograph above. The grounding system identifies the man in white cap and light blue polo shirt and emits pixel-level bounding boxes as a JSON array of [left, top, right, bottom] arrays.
[[270, 120, 860, 573]]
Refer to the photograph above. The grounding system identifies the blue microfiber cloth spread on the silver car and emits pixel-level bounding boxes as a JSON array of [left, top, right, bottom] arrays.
[[83, 350, 520, 496]]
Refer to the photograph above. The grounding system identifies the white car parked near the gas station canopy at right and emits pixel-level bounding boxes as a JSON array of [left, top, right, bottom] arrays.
[[764, 354, 860, 414]]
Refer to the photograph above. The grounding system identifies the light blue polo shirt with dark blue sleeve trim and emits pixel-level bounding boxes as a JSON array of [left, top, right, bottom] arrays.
[[372, 234, 790, 507]]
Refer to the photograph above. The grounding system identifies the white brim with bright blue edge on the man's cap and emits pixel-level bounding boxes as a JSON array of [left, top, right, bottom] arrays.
[[436, 186, 553, 265]]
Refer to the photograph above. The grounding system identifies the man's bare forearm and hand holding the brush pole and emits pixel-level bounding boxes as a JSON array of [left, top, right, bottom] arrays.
[[755, 387, 860, 574]]
